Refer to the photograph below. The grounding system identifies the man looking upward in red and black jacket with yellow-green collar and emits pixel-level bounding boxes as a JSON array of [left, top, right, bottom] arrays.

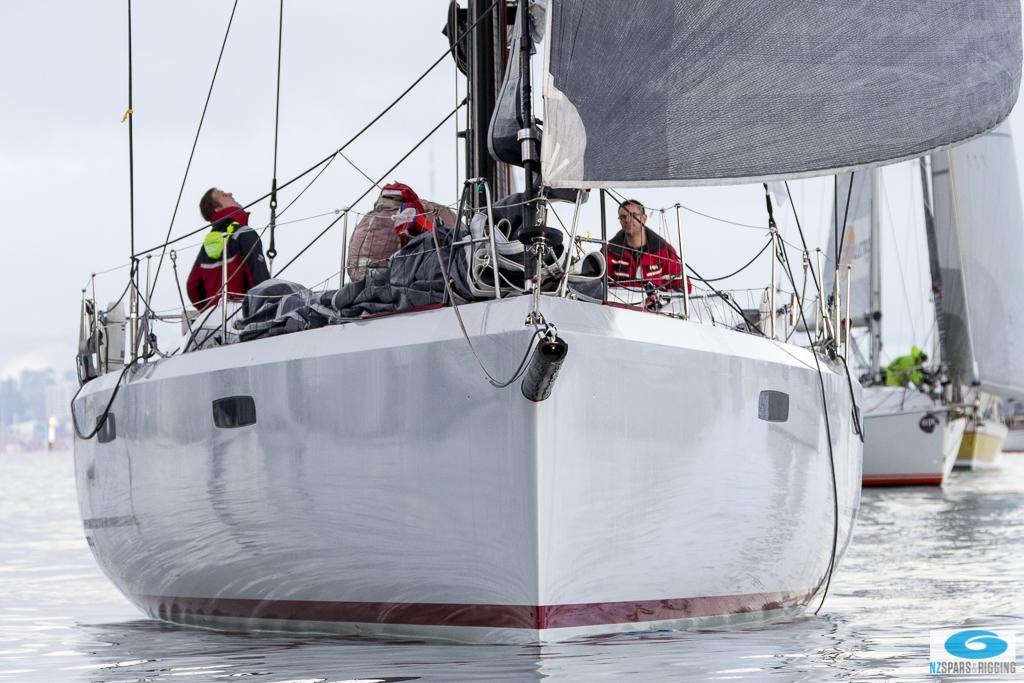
[[188, 187, 270, 310]]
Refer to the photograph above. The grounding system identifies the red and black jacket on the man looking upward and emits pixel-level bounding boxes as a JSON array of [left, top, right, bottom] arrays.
[[188, 207, 270, 310]]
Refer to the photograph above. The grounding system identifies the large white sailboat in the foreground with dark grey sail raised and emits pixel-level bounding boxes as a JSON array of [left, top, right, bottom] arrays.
[[74, 0, 1020, 642]]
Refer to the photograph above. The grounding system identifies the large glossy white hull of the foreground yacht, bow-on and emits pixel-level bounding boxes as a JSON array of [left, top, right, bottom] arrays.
[[75, 297, 861, 642]]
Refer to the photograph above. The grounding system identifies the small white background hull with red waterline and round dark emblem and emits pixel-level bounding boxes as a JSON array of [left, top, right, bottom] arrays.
[[863, 387, 967, 486]]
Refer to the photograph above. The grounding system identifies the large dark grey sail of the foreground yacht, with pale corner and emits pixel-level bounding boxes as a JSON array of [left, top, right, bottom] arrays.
[[542, 0, 1021, 187]]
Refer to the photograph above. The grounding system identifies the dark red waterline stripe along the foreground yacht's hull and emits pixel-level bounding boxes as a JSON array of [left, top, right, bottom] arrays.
[[135, 593, 810, 630]]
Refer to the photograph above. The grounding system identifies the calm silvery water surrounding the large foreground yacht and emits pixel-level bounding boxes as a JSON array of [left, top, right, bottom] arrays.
[[0, 454, 1024, 683]]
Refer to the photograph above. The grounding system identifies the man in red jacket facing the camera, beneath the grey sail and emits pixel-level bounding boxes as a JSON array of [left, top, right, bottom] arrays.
[[605, 200, 689, 289]]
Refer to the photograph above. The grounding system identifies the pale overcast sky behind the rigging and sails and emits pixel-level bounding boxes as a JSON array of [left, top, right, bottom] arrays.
[[0, 0, 1024, 377]]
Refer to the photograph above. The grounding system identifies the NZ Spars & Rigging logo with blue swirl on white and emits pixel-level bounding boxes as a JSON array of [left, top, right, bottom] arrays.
[[928, 629, 1017, 676]]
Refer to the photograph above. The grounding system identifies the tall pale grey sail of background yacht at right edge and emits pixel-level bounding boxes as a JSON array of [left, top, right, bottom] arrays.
[[932, 124, 1024, 399]]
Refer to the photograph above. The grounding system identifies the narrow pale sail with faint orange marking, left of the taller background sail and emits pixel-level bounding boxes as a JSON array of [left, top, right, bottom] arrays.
[[824, 171, 873, 327]]
